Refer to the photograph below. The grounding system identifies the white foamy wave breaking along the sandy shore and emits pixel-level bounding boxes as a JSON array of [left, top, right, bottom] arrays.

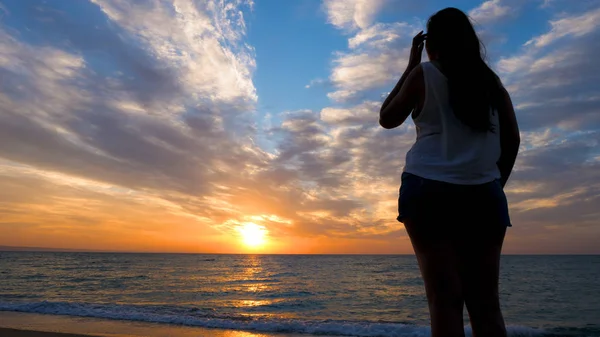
[[0, 301, 543, 337]]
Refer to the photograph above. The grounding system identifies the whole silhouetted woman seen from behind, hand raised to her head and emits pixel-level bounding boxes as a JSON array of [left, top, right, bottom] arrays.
[[379, 8, 520, 337]]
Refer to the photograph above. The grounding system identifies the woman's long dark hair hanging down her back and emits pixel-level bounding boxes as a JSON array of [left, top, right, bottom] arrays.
[[427, 7, 501, 132]]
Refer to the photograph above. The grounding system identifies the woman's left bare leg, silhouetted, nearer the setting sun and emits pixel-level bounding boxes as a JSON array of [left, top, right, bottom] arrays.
[[404, 221, 465, 337]]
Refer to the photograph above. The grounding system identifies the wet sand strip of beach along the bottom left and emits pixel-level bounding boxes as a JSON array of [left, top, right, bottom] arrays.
[[0, 311, 311, 337]]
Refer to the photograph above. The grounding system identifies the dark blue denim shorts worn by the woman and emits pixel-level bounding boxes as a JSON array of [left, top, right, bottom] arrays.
[[397, 172, 512, 227]]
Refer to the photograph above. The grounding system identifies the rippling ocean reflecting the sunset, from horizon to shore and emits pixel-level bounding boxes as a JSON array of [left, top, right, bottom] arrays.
[[0, 252, 600, 337]]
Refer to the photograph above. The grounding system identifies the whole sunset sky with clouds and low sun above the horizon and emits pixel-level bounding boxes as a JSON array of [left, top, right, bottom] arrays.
[[0, 0, 600, 253]]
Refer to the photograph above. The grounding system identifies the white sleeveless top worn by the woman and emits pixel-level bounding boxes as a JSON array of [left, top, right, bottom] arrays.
[[404, 62, 500, 185]]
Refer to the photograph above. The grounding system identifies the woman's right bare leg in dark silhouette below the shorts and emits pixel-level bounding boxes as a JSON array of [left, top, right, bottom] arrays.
[[460, 223, 506, 337]]
